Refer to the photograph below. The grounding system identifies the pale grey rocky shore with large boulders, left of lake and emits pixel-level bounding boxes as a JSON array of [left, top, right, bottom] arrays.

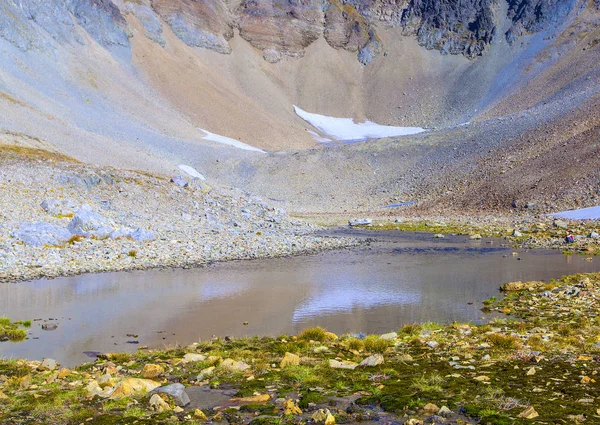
[[0, 149, 356, 282]]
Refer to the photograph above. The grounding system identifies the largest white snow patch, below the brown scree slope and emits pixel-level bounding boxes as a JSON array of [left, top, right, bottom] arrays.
[[294, 105, 426, 142]]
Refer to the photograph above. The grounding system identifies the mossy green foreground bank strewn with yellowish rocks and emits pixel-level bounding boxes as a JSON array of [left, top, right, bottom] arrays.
[[0, 274, 600, 425]]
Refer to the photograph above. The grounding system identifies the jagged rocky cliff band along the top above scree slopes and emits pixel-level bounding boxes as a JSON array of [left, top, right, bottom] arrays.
[[0, 0, 580, 64]]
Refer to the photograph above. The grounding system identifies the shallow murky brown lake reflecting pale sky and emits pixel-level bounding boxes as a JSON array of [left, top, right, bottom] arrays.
[[0, 230, 600, 366]]
